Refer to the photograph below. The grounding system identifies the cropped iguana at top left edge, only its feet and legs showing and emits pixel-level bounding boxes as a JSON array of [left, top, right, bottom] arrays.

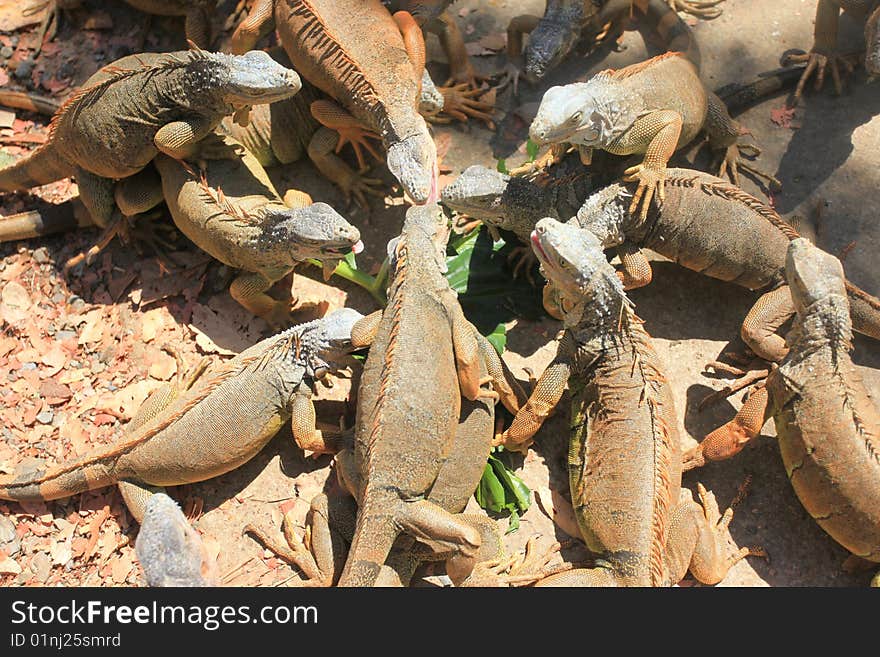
[[25, 0, 217, 55]]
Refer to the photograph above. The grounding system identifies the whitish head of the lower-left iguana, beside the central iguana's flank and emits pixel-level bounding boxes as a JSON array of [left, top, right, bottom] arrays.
[[300, 308, 363, 379]]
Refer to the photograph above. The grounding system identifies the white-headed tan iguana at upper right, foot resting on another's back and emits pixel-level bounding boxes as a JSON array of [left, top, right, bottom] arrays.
[[529, 53, 772, 219]]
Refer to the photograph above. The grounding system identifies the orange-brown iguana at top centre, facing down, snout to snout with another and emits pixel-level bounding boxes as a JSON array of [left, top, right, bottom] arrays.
[[232, 0, 439, 204]]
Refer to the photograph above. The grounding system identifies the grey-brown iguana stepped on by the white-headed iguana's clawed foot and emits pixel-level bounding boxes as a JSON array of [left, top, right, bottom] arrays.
[[576, 169, 880, 361]]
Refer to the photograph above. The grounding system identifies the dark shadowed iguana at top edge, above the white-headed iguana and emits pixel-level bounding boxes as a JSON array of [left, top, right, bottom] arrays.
[[499, 0, 723, 94]]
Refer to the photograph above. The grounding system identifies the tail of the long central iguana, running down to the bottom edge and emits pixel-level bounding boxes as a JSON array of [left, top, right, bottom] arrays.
[[339, 489, 401, 586]]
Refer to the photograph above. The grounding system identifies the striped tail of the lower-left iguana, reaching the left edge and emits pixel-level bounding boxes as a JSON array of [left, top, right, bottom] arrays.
[[0, 456, 118, 502]]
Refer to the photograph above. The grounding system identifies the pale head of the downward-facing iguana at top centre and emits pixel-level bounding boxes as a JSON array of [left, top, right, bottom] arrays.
[[386, 116, 439, 205]]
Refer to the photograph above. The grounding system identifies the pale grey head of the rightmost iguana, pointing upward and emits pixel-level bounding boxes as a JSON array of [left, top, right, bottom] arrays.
[[785, 237, 846, 312]]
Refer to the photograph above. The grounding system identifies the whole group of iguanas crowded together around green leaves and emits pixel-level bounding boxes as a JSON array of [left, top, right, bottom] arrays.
[[0, 0, 880, 586]]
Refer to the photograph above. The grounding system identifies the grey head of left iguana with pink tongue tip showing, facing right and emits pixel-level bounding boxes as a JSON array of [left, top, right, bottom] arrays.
[[267, 203, 364, 274]]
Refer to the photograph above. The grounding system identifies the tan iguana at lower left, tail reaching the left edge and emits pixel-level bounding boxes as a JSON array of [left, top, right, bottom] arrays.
[[0, 308, 361, 522]]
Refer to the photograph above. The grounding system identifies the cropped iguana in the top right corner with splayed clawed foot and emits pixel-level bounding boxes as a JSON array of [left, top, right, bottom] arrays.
[[787, 0, 880, 102]]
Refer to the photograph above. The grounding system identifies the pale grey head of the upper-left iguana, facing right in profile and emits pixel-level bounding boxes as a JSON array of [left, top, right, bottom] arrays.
[[218, 50, 302, 106]]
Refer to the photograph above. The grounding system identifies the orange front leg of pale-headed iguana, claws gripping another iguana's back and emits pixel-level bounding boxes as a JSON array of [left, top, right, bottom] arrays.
[[607, 110, 682, 221]]
